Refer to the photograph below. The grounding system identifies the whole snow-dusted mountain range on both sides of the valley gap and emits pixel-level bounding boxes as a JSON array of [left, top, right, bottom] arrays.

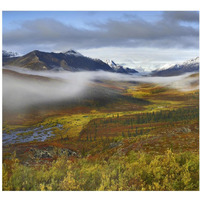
[[2, 50, 199, 76]]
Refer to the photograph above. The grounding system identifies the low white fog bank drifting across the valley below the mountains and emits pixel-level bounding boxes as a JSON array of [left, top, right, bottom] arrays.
[[3, 67, 198, 109]]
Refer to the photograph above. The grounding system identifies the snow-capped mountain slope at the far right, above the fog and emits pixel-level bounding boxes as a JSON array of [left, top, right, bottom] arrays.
[[152, 57, 199, 76]]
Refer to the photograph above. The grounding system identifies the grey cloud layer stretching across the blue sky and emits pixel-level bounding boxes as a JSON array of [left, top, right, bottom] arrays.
[[3, 11, 199, 50]]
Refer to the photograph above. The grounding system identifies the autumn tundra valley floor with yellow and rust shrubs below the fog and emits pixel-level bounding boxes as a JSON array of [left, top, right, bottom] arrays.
[[3, 71, 199, 191]]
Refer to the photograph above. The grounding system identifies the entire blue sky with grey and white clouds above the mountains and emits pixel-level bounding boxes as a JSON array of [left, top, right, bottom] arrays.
[[3, 11, 199, 71]]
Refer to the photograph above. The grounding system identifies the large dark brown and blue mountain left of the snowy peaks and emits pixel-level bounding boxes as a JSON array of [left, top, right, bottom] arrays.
[[3, 50, 113, 72]]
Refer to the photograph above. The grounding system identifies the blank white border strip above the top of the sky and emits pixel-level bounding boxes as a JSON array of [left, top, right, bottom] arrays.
[[1, 0, 200, 11]]
